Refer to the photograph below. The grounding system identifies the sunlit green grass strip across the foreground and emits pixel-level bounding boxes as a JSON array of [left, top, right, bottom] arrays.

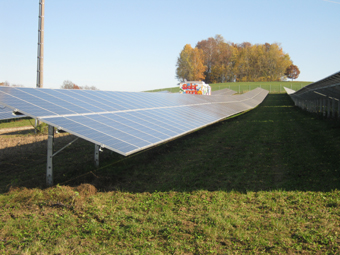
[[0, 187, 340, 254]]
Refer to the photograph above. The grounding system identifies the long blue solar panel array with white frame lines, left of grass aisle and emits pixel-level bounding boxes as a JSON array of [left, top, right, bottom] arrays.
[[0, 87, 268, 156]]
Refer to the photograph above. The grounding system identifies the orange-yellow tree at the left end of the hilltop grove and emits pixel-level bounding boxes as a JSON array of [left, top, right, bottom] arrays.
[[176, 44, 206, 81]]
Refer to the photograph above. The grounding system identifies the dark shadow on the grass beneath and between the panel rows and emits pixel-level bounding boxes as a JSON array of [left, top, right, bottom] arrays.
[[0, 94, 340, 193]]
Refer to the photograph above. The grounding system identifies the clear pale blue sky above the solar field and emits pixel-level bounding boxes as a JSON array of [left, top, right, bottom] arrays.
[[0, 0, 340, 91]]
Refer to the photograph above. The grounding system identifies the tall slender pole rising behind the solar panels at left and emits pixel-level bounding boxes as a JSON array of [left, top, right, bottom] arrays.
[[36, 0, 45, 88]]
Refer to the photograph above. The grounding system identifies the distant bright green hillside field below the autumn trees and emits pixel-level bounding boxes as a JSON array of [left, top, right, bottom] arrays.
[[146, 81, 311, 94]]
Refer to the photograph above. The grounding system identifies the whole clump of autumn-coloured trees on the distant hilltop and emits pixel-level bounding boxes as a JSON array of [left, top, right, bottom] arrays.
[[176, 35, 300, 83]]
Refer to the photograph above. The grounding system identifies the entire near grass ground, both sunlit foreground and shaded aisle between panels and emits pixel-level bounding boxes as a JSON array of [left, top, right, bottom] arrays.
[[0, 91, 340, 254]]
